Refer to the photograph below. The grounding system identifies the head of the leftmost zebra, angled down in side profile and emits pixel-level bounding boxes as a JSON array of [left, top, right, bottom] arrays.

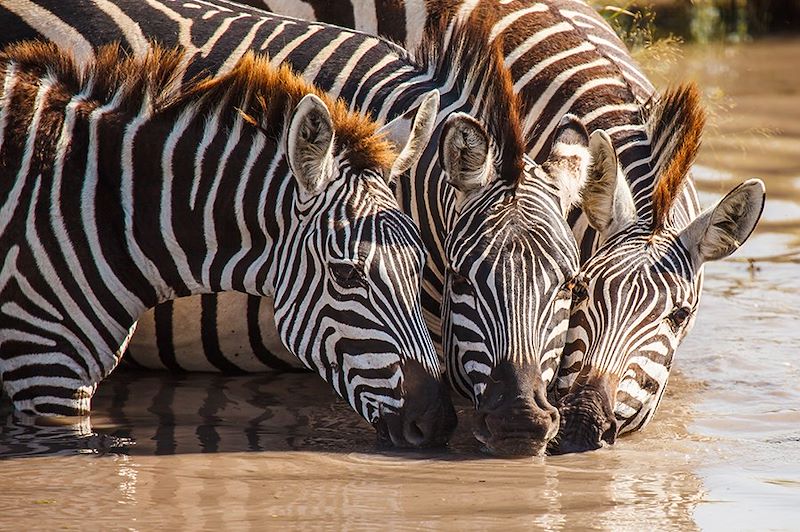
[[274, 95, 455, 446]]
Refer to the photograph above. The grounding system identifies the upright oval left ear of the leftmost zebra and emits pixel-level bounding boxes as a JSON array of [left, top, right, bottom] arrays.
[[286, 94, 333, 196]]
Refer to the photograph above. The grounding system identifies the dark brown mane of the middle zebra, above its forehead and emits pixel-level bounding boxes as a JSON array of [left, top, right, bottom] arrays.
[[413, 17, 525, 185]]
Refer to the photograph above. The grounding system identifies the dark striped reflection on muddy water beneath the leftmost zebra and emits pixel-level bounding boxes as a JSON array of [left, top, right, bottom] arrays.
[[0, 368, 481, 459]]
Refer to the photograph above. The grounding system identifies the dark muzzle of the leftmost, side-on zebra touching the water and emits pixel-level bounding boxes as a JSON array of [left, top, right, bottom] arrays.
[[372, 360, 458, 449]]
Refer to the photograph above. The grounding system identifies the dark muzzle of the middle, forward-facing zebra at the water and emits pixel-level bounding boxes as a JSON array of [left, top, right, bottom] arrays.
[[473, 360, 560, 456]]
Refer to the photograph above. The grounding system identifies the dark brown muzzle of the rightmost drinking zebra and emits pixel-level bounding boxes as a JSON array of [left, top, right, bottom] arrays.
[[548, 378, 619, 454]]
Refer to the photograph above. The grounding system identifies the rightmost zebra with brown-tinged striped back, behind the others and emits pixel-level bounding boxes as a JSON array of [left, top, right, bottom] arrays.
[[245, 0, 763, 451]]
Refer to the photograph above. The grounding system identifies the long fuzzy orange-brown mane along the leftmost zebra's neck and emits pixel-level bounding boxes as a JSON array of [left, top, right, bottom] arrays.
[[0, 41, 397, 175]]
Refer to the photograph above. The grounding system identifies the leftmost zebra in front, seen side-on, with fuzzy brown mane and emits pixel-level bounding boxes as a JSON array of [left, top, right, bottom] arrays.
[[0, 42, 455, 446]]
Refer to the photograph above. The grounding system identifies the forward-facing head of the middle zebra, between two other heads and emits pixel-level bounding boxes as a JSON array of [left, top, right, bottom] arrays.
[[439, 114, 589, 455]]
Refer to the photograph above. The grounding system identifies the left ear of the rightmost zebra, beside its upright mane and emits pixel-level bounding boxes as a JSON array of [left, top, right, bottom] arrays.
[[581, 130, 637, 242]]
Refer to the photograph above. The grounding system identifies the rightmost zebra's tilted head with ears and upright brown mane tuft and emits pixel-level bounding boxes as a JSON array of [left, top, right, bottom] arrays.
[[558, 85, 764, 452]]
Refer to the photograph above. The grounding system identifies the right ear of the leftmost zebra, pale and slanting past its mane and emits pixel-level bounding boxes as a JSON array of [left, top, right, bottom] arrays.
[[378, 90, 439, 179]]
